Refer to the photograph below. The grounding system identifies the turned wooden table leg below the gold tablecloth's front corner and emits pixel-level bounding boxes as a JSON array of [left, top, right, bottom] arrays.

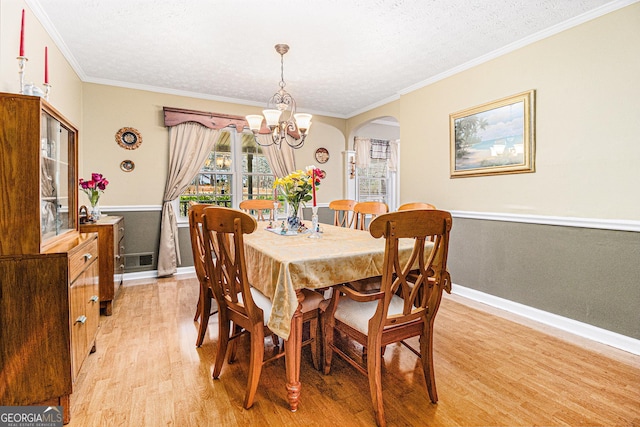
[[284, 290, 304, 412]]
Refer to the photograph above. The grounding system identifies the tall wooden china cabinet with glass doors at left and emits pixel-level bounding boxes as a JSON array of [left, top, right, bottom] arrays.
[[0, 93, 100, 422]]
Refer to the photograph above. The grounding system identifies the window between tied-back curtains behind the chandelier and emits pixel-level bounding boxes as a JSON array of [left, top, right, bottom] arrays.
[[178, 128, 274, 222]]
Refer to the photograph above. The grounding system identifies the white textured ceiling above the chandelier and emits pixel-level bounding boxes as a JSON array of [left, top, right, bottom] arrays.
[[27, 0, 636, 118]]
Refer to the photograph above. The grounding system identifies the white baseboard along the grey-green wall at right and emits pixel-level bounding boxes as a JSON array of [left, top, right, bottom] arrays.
[[451, 284, 640, 355]]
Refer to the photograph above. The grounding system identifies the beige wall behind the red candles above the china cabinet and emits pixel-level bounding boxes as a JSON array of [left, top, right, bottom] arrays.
[[0, 0, 83, 125]]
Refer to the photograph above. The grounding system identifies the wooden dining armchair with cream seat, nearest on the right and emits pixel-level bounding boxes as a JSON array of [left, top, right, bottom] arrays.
[[322, 210, 452, 426]]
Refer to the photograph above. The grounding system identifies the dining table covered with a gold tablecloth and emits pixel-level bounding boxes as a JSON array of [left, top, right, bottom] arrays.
[[244, 222, 420, 411]]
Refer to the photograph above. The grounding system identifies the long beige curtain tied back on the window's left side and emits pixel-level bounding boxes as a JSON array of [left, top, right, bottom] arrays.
[[158, 122, 220, 276]]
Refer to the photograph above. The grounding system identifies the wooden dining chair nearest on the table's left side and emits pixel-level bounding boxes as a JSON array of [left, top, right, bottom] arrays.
[[203, 206, 323, 409]]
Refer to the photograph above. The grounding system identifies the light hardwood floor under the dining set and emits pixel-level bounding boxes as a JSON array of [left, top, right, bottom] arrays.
[[69, 276, 640, 427]]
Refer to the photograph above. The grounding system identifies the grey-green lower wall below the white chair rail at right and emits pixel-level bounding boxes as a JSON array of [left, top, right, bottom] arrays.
[[448, 218, 640, 339]]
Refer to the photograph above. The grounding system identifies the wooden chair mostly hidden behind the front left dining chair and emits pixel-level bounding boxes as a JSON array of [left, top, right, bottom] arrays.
[[189, 204, 218, 347]]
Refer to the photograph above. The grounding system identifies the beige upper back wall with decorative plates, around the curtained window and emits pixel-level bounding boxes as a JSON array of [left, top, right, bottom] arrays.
[[80, 83, 345, 206]]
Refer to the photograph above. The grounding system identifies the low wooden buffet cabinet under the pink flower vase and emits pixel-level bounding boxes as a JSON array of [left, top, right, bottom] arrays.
[[80, 216, 124, 316]]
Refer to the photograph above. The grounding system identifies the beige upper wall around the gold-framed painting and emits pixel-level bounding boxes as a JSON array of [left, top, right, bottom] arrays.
[[347, 4, 640, 220]]
